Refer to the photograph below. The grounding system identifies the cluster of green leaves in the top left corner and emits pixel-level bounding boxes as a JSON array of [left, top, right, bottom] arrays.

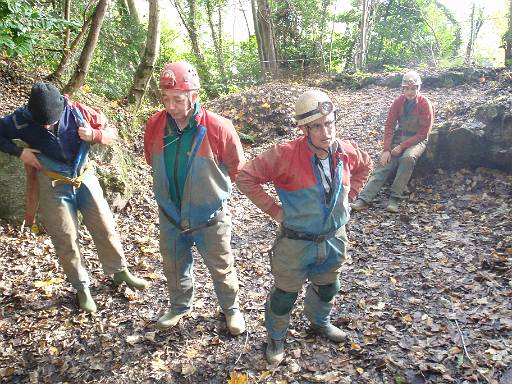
[[0, 0, 77, 56]]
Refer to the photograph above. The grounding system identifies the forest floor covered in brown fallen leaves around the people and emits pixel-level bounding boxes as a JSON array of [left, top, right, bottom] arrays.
[[0, 65, 512, 384]]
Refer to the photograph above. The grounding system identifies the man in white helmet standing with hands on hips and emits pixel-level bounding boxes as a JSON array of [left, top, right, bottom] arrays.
[[237, 90, 372, 364]]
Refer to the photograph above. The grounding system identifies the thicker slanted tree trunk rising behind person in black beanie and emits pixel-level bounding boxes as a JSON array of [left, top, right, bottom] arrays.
[[64, 0, 110, 95]]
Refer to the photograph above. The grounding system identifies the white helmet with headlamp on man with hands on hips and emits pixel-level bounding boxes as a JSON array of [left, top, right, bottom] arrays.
[[295, 89, 334, 126]]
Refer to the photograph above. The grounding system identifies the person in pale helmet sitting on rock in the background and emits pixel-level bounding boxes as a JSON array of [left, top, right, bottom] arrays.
[[351, 71, 434, 213]]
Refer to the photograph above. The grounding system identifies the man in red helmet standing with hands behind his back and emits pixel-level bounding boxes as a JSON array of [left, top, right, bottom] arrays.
[[144, 62, 245, 335]]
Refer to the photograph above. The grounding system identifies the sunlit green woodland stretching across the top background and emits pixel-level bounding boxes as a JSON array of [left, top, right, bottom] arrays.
[[0, 0, 512, 99]]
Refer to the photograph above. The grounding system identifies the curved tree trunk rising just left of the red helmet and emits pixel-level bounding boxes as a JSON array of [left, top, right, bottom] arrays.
[[128, 0, 160, 108]]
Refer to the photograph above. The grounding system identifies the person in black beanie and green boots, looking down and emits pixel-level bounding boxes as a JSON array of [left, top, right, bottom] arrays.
[[0, 83, 149, 312]]
